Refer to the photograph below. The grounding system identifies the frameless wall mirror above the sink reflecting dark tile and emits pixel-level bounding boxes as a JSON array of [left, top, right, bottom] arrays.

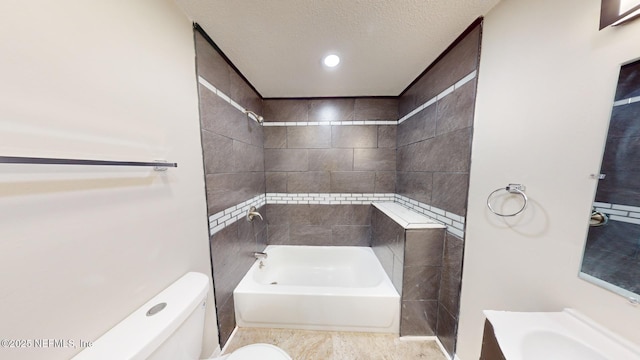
[[580, 60, 640, 301]]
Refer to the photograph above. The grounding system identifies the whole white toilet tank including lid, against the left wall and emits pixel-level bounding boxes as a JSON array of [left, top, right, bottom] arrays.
[[73, 272, 209, 360]]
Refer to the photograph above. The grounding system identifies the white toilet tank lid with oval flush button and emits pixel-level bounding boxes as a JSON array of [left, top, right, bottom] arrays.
[[73, 272, 209, 360]]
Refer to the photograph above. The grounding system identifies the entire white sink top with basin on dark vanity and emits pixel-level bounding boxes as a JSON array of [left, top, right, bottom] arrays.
[[484, 309, 640, 360]]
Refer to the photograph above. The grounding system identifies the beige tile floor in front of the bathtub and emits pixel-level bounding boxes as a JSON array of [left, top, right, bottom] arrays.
[[224, 328, 447, 360]]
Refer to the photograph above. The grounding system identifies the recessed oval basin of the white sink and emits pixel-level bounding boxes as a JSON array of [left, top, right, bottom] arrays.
[[522, 331, 607, 360]]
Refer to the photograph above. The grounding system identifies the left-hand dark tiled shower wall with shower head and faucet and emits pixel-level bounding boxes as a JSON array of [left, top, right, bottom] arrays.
[[195, 32, 267, 344]]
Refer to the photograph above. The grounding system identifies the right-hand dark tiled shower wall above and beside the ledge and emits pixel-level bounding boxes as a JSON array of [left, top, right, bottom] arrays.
[[396, 23, 481, 354]]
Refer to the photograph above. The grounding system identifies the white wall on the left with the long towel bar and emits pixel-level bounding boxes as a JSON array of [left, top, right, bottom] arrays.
[[0, 0, 217, 359]]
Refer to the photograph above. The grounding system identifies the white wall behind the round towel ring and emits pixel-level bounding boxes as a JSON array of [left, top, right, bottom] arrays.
[[458, 0, 640, 360]]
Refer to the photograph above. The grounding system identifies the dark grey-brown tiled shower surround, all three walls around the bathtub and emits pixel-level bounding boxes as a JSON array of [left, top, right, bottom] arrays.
[[196, 18, 480, 353]]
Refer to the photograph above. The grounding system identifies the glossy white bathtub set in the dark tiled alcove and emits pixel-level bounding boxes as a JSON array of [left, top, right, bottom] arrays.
[[233, 245, 400, 334]]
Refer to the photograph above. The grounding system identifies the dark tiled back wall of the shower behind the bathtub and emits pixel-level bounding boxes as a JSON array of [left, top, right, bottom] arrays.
[[263, 98, 398, 246]]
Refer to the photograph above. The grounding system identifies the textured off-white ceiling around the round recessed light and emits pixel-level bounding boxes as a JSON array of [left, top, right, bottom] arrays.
[[176, 0, 499, 98]]
